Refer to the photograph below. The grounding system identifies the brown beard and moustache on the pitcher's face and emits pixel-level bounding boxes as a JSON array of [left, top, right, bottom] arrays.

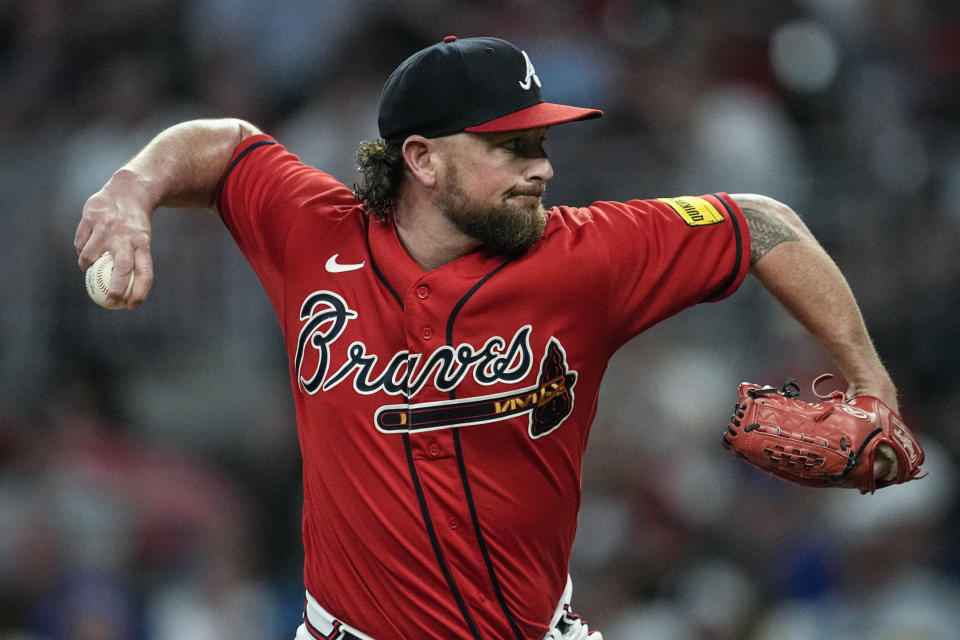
[[438, 167, 547, 256]]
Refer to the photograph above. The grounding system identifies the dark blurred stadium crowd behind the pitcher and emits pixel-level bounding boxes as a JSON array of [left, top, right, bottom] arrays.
[[0, 0, 960, 640]]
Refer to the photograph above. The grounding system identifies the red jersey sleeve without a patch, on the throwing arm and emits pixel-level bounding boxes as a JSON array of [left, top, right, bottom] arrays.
[[215, 134, 357, 306]]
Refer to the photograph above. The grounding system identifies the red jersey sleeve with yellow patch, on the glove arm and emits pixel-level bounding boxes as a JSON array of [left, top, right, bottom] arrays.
[[590, 193, 750, 346]]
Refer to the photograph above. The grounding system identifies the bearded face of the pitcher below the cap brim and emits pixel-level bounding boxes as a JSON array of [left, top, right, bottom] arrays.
[[437, 127, 553, 255]]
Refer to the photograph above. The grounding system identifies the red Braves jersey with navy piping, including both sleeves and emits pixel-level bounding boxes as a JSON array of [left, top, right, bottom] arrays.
[[217, 135, 750, 640]]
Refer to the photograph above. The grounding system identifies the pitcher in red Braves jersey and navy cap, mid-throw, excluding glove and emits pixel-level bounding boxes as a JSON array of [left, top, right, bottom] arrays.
[[75, 36, 908, 640]]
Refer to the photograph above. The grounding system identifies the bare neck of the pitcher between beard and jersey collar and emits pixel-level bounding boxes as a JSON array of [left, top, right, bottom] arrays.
[[393, 191, 480, 271]]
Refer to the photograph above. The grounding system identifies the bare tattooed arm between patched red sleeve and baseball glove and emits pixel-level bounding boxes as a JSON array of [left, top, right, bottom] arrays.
[[734, 195, 897, 410]]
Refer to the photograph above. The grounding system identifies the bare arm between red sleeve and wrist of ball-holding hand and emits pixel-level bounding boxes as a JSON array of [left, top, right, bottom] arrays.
[[117, 119, 259, 211]]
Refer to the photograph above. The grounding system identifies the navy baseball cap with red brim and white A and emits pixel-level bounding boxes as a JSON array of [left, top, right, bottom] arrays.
[[378, 36, 603, 143]]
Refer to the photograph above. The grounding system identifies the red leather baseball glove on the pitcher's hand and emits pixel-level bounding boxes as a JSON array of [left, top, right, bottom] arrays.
[[723, 374, 923, 493]]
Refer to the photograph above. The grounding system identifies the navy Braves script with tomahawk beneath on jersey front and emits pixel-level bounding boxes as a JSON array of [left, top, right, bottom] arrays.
[[294, 291, 577, 438]]
